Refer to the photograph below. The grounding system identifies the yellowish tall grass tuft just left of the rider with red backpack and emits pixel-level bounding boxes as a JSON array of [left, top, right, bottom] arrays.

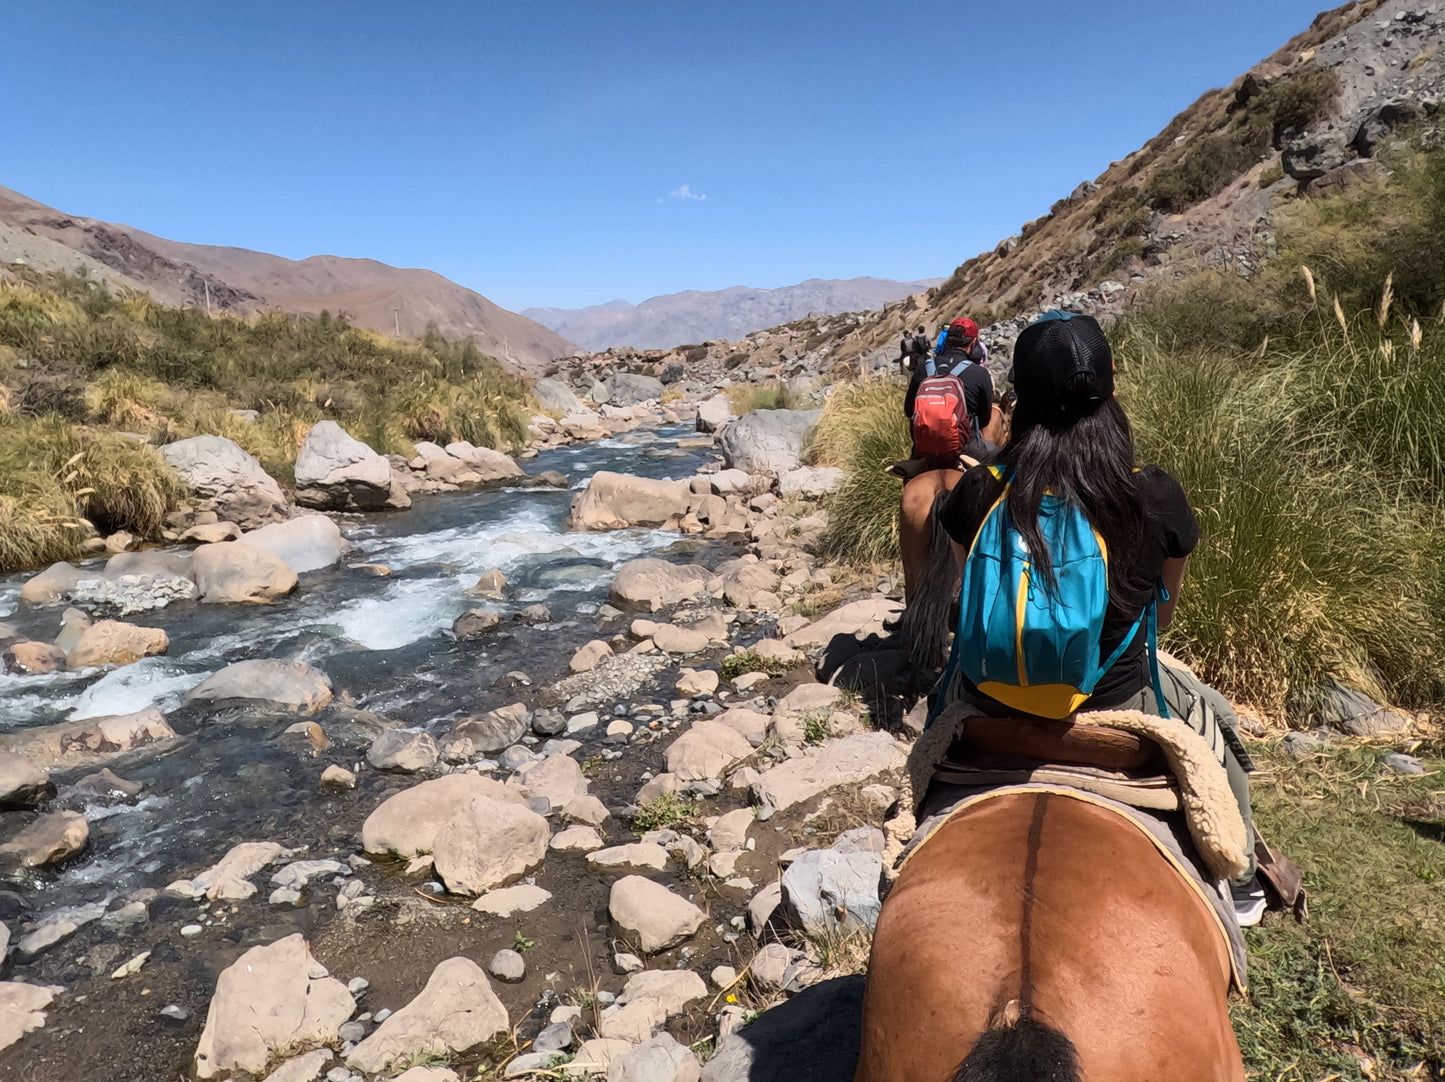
[[809, 378, 913, 563]]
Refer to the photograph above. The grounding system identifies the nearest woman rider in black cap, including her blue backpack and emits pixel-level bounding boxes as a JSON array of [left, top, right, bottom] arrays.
[[919, 312, 1264, 925]]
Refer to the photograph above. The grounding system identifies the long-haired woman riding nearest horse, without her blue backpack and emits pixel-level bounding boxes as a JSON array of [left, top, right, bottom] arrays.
[[938, 312, 1264, 923]]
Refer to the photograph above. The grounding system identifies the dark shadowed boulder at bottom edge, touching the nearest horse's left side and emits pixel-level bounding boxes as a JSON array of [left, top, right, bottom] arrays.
[[702, 977, 863, 1082]]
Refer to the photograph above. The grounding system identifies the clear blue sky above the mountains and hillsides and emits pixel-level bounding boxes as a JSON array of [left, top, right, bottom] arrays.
[[0, 0, 1325, 309]]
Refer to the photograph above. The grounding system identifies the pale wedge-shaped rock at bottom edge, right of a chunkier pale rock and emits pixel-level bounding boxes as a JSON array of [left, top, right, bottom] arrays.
[[347, 958, 509, 1075]]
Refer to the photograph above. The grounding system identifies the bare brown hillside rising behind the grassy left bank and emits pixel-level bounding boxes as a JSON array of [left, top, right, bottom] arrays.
[[0, 188, 575, 371]]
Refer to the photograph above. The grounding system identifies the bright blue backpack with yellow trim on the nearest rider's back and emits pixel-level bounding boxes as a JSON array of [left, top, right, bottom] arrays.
[[935, 467, 1169, 718]]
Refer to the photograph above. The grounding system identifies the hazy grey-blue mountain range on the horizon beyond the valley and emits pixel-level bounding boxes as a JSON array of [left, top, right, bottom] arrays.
[[522, 277, 942, 350]]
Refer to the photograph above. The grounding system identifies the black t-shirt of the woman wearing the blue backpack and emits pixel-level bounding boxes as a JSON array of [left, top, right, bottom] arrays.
[[939, 467, 1199, 709]]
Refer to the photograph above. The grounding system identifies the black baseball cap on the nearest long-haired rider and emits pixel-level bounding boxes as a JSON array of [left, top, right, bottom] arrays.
[[1013, 311, 1114, 416]]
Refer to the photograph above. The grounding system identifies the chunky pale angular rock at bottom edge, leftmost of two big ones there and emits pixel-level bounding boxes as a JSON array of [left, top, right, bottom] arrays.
[[195, 933, 355, 1079]]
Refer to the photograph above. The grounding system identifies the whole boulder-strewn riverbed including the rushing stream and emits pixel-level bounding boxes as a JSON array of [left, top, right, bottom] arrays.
[[0, 380, 924, 1082]]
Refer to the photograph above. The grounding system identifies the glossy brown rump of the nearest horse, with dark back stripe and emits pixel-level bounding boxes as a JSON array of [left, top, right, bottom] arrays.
[[854, 793, 1244, 1082]]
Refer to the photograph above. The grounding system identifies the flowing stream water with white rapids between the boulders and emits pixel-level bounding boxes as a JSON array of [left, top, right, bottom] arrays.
[[0, 426, 711, 914]]
